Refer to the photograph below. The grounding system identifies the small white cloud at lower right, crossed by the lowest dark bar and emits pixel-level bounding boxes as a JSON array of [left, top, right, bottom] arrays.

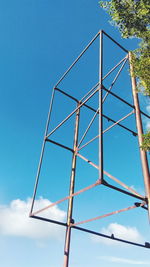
[[92, 223, 143, 245]]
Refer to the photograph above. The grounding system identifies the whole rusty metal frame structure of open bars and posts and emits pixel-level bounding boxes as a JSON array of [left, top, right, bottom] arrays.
[[30, 30, 150, 267]]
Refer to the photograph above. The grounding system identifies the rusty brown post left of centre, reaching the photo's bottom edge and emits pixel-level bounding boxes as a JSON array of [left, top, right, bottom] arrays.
[[64, 103, 80, 267]]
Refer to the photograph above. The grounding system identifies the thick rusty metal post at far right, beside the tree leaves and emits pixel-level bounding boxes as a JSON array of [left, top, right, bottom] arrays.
[[129, 52, 150, 220]]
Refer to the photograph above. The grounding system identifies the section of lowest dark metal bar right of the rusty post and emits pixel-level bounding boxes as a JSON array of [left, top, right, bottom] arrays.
[[72, 226, 150, 248]]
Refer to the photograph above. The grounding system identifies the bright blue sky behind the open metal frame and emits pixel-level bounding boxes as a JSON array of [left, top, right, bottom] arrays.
[[0, 0, 150, 267]]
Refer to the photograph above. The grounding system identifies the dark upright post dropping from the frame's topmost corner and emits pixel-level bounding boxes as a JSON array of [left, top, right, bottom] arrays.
[[99, 31, 103, 182]]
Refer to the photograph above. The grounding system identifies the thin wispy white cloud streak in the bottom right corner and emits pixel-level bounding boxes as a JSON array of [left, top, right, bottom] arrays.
[[99, 257, 150, 266]]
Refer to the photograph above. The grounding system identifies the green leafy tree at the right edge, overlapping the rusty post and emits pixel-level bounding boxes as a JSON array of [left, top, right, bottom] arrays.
[[100, 0, 150, 151]]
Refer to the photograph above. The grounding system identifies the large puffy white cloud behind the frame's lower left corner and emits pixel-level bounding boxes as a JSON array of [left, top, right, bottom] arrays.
[[0, 198, 66, 239]]
